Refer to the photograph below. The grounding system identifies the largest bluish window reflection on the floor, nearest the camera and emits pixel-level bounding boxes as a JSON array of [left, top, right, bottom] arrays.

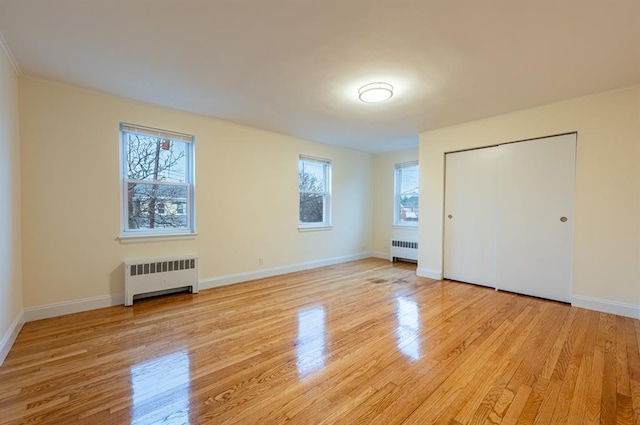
[[131, 349, 190, 425]]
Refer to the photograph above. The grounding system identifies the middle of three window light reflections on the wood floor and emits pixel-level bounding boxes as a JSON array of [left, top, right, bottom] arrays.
[[296, 306, 326, 376]]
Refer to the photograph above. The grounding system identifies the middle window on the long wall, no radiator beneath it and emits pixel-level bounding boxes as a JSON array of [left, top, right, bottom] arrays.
[[298, 155, 331, 227]]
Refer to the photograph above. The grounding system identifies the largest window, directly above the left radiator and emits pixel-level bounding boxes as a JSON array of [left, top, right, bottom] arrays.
[[120, 124, 195, 236]]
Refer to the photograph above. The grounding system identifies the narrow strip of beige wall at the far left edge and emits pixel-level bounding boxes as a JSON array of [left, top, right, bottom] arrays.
[[0, 49, 22, 342]]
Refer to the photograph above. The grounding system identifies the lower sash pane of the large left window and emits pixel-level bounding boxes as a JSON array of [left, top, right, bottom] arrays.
[[127, 183, 188, 229]]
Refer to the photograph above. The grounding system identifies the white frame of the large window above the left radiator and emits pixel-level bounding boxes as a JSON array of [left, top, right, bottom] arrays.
[[120, 123, 196, 240]]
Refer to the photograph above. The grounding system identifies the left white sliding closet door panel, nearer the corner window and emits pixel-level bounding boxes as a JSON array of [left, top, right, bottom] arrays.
[[443, 147, 500, 287]]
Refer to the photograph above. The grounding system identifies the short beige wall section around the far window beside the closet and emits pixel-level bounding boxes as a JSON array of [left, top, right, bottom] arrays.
[[373, 148, 418, 258]]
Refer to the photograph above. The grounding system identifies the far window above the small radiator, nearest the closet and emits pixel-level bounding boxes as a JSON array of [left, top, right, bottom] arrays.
[[394, 162, 420, 226]]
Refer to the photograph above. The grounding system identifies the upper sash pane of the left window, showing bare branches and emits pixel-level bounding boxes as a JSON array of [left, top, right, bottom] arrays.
[[125, 133, 188, 183]]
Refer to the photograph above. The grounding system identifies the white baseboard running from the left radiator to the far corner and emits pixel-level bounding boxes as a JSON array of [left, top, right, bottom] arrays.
[[198, 253, 370, 290]]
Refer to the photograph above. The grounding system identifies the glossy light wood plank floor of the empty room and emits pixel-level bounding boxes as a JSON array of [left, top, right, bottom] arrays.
[[0, 259, 640, 425]]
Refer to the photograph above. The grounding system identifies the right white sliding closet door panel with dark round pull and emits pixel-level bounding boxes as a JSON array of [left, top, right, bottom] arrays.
[[496, 134, 576, 302]]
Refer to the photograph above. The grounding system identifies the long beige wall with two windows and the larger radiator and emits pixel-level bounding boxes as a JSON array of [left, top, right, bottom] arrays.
[[20, 79, 372, 307]]
